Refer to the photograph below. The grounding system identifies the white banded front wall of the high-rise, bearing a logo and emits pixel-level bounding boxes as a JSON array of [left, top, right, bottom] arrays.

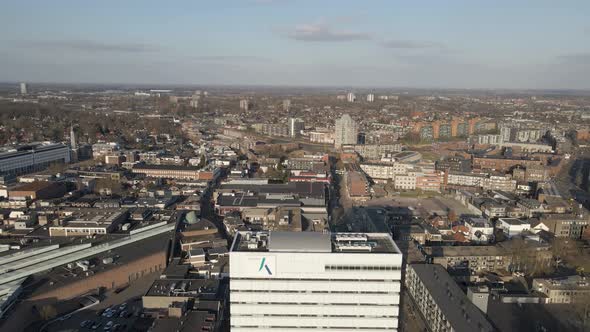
[[230, 251, 402, 332]]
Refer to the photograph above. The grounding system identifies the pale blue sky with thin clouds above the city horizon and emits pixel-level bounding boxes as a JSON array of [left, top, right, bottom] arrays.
[[0, 0, 590, 89]]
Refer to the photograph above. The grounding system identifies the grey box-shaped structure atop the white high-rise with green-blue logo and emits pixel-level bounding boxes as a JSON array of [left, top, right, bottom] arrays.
[[268, 232, 332, 252]]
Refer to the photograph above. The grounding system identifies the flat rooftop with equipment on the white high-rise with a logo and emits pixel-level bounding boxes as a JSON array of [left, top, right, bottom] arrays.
[[231, 231, 401, 254]]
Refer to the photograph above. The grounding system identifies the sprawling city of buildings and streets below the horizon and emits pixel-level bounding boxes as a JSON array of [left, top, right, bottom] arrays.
[[0, 72, 590, 332]]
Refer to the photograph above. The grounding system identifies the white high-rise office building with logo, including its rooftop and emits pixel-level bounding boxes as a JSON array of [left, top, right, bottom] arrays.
[[230, 231, 402, 332]]
